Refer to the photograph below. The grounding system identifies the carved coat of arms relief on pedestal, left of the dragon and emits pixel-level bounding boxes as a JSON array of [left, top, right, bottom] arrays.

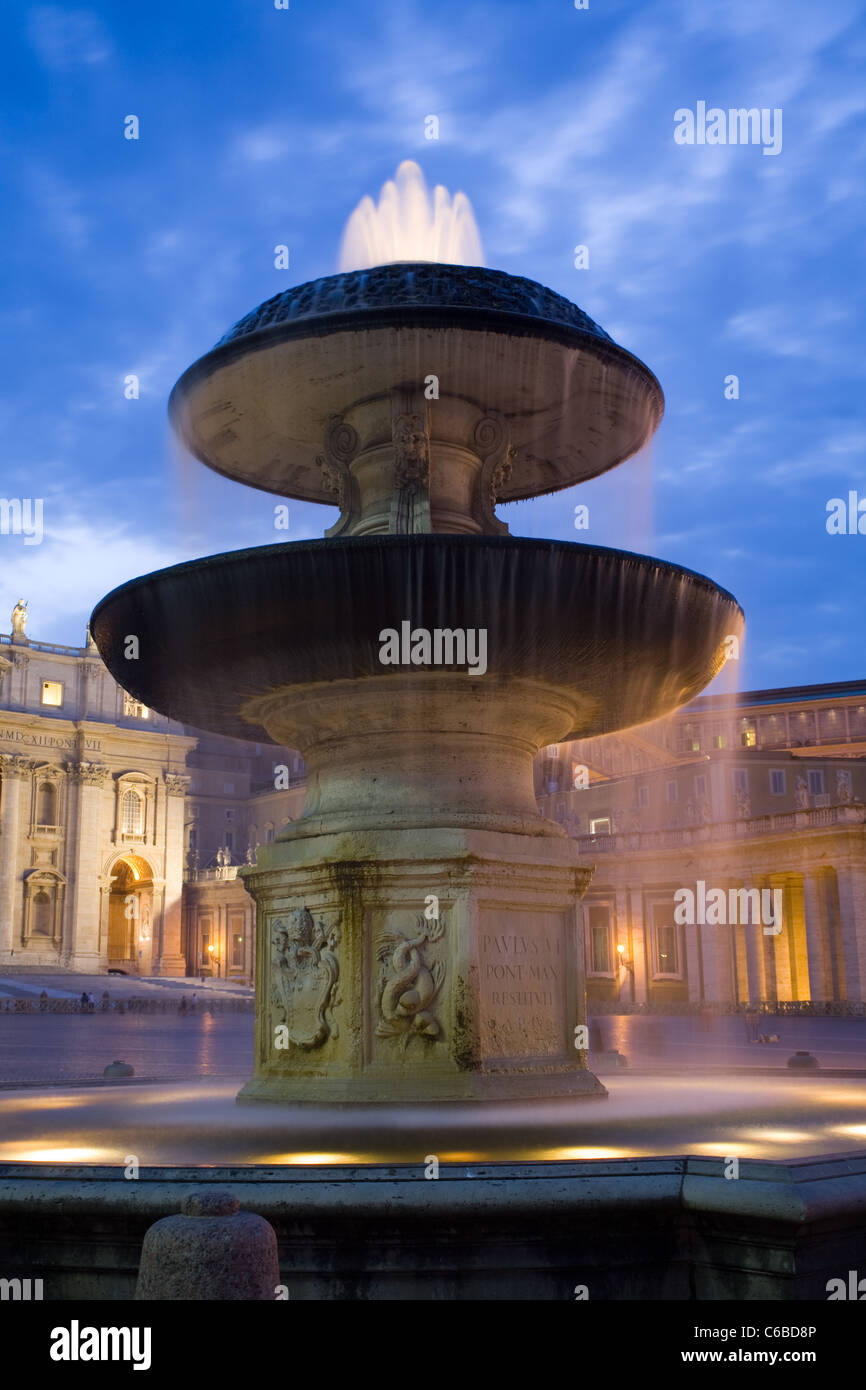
[[271, 908, 341, 1049]]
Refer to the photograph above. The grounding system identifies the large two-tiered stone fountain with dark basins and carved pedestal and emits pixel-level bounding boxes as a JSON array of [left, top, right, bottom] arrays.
[[90, 170, 742, 1139]]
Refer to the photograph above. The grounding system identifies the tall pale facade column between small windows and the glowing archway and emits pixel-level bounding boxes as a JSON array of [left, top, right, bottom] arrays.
[[64, 762, 110, 974]]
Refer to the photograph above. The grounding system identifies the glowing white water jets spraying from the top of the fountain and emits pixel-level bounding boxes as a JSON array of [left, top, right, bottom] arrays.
[[339, 160, 484, 271]]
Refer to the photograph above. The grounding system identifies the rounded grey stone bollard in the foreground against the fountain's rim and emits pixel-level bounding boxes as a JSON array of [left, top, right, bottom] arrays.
[[135, 1190, 279, 1302]]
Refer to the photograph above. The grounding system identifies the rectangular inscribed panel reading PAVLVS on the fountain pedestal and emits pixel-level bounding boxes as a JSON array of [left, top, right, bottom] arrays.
[[478, 908, 567, 1056]]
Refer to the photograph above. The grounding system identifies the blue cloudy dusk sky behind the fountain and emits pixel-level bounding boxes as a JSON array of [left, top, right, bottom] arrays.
[[0, 0, 866, 688]]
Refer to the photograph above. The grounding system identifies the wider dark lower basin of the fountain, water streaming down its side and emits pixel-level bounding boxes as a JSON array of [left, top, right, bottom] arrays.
[[90, 535, 742, 742]]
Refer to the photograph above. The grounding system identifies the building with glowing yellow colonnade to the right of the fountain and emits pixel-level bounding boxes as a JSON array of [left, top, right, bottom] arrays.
[[537, 682, 866, 1006]]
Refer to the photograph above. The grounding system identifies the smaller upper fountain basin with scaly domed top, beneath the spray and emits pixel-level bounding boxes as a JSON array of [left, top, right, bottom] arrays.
[[170, 261, 663, 511]]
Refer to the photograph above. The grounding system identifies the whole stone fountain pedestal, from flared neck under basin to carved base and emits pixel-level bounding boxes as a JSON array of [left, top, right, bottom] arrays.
[[233, 673, 606, 1123]]
